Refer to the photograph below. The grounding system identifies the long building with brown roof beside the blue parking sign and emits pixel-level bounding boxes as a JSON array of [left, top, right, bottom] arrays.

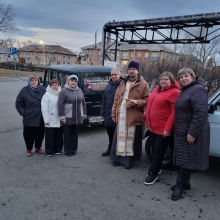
[[18, 45, 77, 65]]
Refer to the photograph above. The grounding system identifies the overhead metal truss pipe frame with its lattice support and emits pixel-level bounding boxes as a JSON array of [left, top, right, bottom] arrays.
[[100, 12, 220, 65]]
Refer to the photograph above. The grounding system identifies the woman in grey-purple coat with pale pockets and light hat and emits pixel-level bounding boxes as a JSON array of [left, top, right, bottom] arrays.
[[58, 75, 86, 156]]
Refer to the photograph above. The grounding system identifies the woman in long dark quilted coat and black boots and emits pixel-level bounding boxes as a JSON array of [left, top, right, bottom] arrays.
[[171, 68, 210, 201]]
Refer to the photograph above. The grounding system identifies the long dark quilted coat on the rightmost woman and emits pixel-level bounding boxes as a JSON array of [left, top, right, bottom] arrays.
[[174, 78, 210, 170]]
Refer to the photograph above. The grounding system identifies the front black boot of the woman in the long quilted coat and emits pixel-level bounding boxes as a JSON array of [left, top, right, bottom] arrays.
[[171, 168, 190, 201]]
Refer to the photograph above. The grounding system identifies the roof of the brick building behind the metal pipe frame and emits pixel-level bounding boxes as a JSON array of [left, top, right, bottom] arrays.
[[81, 42, 174, 53]]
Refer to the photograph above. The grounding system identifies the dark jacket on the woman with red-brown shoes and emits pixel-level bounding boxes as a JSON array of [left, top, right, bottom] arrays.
[[15, 86, 46, 127]]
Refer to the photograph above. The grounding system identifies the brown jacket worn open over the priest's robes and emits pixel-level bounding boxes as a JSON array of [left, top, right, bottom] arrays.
[[112, 75, 149, 126]]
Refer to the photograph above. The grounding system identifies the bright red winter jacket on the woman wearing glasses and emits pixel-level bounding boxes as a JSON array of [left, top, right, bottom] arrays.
[[145, 82, 180, 135]]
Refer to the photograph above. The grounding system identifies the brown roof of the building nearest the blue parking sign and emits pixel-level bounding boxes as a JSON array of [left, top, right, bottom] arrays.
[[18, 45, 77, 56]]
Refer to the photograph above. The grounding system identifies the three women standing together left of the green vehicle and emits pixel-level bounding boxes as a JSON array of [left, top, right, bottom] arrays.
[[15, 74, 86, 157]]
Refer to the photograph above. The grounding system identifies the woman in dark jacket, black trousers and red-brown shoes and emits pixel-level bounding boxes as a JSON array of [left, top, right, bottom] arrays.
[[15, 74, 46, 157]]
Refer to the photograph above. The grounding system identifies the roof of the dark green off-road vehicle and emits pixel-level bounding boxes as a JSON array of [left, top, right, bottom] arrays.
[[48, 65, 113, 73]]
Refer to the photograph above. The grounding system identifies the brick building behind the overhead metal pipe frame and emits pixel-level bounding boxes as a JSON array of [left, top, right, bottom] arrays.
[[81, 42, 176, 68]]
